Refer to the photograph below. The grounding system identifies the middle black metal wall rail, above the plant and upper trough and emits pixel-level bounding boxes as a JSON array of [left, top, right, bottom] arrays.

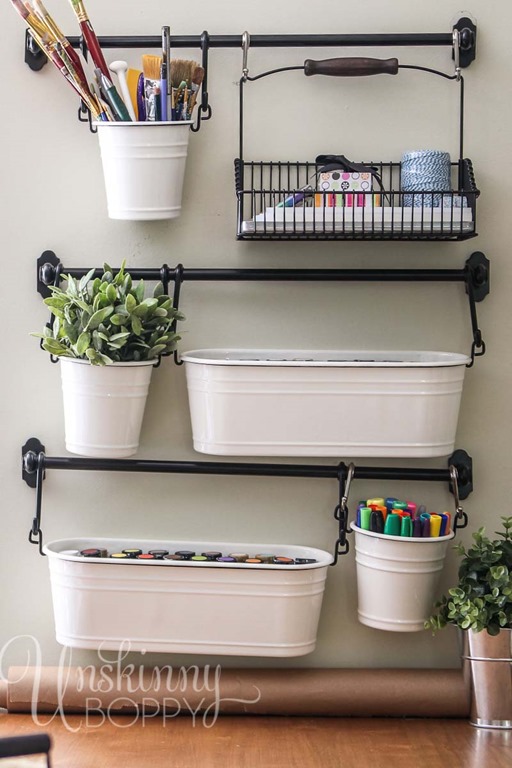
[[37, 251, 490, 367]]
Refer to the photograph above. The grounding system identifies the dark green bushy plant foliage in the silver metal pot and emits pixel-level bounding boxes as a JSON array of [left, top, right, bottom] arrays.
[[425, 517, 512, 635]]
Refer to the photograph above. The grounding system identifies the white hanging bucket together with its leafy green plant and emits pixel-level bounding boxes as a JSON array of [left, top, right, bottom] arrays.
[[33, 262, 184, 458]]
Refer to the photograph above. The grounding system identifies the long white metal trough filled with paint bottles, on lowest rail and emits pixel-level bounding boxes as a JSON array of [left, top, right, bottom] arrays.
[[44, 539, 333, 656]]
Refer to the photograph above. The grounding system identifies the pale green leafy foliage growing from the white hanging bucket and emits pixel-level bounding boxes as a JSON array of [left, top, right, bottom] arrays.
[[32, 262, 184, 365]]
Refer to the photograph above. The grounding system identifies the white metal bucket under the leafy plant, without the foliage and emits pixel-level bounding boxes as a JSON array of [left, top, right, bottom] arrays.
[[60, 357, 155, 459]]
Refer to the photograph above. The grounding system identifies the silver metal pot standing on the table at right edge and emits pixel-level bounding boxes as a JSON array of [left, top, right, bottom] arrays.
[[463, 629, 512, 729]]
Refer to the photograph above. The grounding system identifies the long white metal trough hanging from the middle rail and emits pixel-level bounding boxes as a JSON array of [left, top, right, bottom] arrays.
[[182, 349, 469, 457]]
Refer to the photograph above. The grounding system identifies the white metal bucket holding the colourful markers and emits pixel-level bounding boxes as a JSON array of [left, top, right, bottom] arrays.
[[351, 523, 455, 632]]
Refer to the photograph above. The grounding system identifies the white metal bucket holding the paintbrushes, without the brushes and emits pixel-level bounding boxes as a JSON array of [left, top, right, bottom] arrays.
[[95, 120, 192, 220]]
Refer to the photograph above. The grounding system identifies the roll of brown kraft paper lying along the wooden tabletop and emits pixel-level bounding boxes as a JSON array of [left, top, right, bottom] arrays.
[[0, 666, 469, 718]]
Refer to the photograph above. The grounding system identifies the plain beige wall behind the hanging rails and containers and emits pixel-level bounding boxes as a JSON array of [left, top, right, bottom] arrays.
[[0, 0, 512, 667]]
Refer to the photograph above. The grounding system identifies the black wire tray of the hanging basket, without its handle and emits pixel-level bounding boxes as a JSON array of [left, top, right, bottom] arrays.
[[235, 159, 479, 240]]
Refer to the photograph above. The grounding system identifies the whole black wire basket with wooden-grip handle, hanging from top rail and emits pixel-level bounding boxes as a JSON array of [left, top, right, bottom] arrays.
[[235, 56, 479, 241]]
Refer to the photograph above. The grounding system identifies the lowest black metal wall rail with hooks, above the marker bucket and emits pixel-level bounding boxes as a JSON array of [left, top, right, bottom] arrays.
[[21, 437, 473, 564]]
